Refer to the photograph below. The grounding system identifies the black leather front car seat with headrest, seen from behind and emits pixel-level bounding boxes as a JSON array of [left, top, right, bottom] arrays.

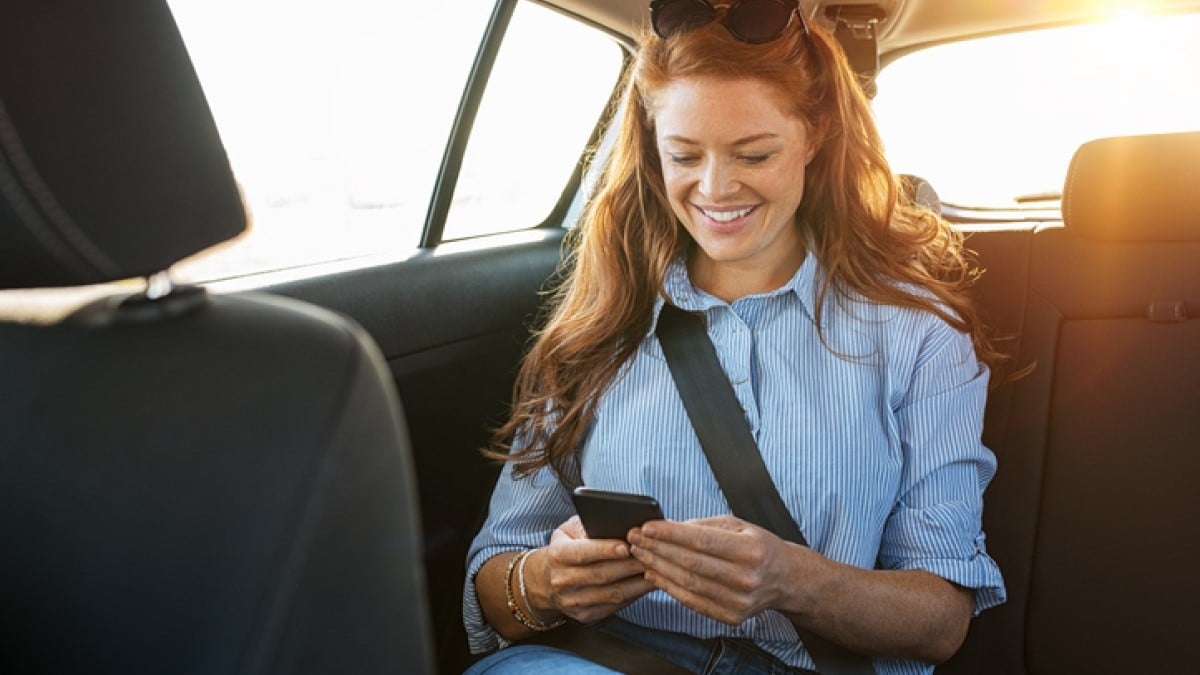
[[0, 0, 434, 674]]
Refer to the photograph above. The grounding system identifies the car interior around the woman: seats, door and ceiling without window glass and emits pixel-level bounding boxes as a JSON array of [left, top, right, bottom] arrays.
[[0, 0, 1200, 675]]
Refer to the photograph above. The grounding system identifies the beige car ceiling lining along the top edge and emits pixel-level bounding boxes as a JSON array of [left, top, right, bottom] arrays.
[[542, 0, 1200, 55]]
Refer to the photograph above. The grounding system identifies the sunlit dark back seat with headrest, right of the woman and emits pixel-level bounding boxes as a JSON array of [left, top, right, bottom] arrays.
[[938, 128, 1200, 674]]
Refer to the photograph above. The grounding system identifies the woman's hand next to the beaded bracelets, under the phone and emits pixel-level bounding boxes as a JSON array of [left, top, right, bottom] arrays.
[[526, 516, 654, 623]]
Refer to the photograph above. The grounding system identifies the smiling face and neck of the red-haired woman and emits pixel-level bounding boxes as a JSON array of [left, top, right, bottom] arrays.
[[653, 77, 816, 300]]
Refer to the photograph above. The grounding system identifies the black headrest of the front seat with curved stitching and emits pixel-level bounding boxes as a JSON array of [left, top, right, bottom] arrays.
[[0, 0, 246, 288]]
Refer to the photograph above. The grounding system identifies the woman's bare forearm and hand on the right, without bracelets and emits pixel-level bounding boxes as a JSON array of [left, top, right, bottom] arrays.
[[629, 515, 974, 663]]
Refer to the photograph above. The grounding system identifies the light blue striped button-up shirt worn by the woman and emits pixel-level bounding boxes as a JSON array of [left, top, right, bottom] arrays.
[[463, 255, 1004, 675]]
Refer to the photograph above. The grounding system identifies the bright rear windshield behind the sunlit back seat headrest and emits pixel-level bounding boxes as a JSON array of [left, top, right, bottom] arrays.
[[875, 16, 1200, 210]]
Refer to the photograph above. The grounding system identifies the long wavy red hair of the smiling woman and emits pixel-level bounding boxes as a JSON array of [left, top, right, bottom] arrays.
[[487, 14, 1003, 478]]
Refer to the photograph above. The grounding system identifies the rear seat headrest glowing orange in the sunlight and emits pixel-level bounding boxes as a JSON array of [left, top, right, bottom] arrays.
[[1062, 132, 1200, 241]]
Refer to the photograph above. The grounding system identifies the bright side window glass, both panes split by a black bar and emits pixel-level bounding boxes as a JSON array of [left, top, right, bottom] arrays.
[[162, 0, 620, 281]]
